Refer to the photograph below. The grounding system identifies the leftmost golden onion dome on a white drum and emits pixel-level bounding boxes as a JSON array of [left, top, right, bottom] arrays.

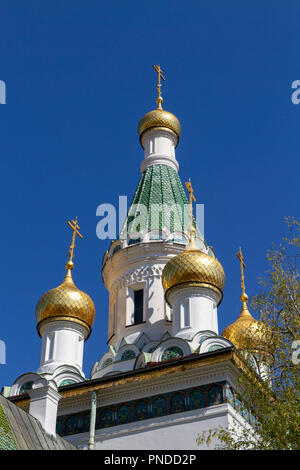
[[35, 268, 95, 336]]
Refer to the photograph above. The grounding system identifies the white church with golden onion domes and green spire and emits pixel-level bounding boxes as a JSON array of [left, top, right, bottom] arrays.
[[3, 66, 267, 450]]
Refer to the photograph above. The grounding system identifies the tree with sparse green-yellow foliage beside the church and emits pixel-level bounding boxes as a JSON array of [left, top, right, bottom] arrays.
[[197, 218, 300, 450]]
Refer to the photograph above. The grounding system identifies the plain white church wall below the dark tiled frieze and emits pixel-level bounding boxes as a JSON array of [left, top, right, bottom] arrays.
[[65, 403, 247, 450]]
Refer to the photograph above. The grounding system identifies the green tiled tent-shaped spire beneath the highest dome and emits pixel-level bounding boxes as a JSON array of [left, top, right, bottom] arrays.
[[120, 165, 203, 239]]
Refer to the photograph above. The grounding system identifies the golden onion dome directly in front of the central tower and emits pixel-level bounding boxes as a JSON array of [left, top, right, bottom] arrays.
[[162, 237, 225, 299]]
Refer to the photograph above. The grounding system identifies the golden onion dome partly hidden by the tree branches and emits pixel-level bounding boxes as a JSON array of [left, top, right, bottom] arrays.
[[222, 293, 271, 352]]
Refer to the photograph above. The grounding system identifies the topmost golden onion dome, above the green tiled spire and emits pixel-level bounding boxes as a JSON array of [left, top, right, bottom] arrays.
[[138, 107, 181, 145]]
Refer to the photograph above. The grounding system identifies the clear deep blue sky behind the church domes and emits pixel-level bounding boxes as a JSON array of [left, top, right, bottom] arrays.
[[0, 0, 300, 385]]
